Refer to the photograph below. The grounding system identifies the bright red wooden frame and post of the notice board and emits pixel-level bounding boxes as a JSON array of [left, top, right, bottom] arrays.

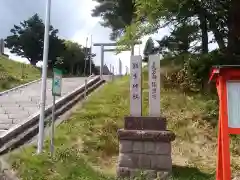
[[210, 66, 240, 180]]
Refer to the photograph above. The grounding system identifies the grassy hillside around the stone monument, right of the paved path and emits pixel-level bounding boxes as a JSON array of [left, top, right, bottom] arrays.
[[3, 66, 240, 180]]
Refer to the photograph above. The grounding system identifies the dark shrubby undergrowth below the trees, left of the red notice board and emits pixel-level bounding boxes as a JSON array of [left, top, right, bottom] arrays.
[[164, 51, 226, 92]]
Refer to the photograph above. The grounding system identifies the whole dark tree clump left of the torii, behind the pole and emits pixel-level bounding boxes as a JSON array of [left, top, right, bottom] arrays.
[[5, 14, 97, 75]]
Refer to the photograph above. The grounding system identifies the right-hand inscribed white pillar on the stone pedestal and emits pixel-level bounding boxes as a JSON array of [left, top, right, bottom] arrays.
[[148, 55, 160, 117]]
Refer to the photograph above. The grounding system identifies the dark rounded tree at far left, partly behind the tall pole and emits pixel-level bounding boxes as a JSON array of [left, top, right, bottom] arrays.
[[5, 14, 63, 66]]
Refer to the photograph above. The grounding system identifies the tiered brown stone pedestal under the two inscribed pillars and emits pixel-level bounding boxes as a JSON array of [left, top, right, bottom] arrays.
[[117, 117, 175, 180]]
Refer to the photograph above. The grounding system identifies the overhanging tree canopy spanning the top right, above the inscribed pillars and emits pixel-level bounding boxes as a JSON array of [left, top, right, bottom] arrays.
[[93, 0, 240, 57]]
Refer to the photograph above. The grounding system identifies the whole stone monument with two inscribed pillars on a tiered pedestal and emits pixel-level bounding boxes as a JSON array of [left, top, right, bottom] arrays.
[[117, 54, 175, 180]]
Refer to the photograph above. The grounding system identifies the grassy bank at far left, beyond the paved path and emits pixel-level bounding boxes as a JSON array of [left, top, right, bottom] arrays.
[[0, 56, 40, 91]]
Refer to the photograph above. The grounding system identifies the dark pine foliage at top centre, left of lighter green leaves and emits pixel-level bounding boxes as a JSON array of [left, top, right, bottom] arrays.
[[92, 0, 135, 40]]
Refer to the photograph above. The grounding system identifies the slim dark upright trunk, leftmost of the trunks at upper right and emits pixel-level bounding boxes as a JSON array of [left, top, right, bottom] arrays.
[[199, 11, 208, 54]]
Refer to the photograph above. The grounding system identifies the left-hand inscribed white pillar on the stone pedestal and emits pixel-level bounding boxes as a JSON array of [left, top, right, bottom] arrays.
[[130, 56, 142, 116]]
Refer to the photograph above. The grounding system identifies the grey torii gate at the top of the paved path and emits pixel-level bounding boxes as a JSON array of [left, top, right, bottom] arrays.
[[93, 41, 142, 77]]
